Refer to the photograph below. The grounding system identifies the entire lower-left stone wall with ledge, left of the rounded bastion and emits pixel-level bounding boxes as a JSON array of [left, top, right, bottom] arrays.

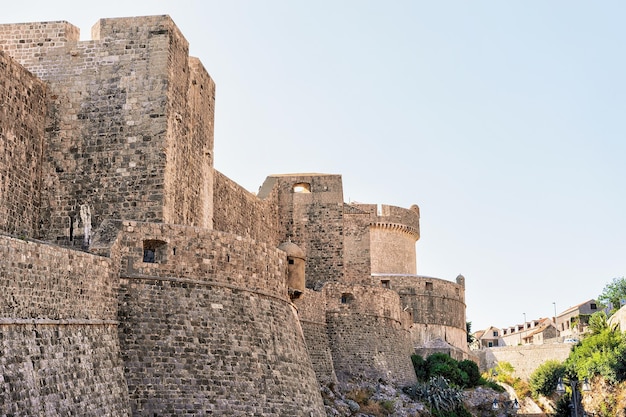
[[0, 236, 130, 417]]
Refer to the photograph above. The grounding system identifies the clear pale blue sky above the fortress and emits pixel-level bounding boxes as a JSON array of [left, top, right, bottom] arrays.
[[0, 0, 626, 330]]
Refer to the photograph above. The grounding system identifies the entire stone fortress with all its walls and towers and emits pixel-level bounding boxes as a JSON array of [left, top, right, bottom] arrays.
[[0, 16, 465, 416]]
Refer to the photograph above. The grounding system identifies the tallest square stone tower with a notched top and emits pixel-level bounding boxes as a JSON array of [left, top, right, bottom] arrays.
[[0, 16, 215, 246]]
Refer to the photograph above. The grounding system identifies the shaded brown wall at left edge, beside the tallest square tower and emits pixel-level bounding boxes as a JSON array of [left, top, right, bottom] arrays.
[[0, 51, 47, 237]]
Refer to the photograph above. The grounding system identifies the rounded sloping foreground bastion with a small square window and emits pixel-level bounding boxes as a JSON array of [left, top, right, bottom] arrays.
[[101, 221, 325, 417]]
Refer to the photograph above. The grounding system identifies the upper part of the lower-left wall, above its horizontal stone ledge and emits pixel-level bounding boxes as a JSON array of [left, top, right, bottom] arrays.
[[0, 236, 118, 320]]
